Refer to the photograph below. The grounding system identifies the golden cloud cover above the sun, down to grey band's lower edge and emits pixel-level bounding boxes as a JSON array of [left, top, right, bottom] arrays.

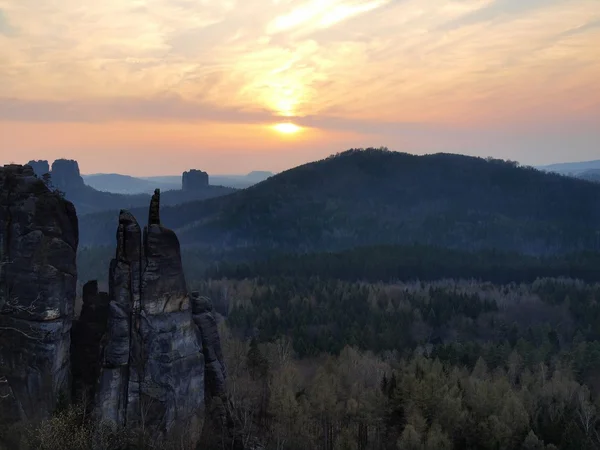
[[0, 0, 600, 144]]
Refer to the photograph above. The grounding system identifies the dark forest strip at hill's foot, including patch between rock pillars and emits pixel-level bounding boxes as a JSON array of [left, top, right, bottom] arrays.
[[77, 245, 600, 290]]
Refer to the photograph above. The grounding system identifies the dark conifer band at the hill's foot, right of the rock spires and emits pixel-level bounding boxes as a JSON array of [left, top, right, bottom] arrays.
[[207, 245, 600, 284]]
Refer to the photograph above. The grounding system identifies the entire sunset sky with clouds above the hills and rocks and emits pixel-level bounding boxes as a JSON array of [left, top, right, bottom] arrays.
[[0, 0, 600, 176]]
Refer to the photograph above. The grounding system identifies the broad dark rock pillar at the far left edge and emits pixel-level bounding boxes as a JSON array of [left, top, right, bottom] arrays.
[[0, 165, 79, 420]]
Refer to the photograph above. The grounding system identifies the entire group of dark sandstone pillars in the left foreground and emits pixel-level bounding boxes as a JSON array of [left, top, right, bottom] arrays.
[[0, 171, 231, 443]]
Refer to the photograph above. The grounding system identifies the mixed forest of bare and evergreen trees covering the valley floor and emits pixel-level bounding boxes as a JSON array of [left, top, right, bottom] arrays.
[[200, 279, 600, 450]]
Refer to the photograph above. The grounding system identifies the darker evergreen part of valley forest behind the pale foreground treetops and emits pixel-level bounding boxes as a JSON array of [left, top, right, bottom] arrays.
[[205, 277, 600, 381]]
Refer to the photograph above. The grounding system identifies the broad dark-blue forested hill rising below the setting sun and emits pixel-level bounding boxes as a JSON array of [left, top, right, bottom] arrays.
[[80, 149, 600, 254]]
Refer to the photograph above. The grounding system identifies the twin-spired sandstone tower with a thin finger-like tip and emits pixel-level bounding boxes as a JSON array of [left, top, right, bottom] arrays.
[[96, 191, 205, 441]]
